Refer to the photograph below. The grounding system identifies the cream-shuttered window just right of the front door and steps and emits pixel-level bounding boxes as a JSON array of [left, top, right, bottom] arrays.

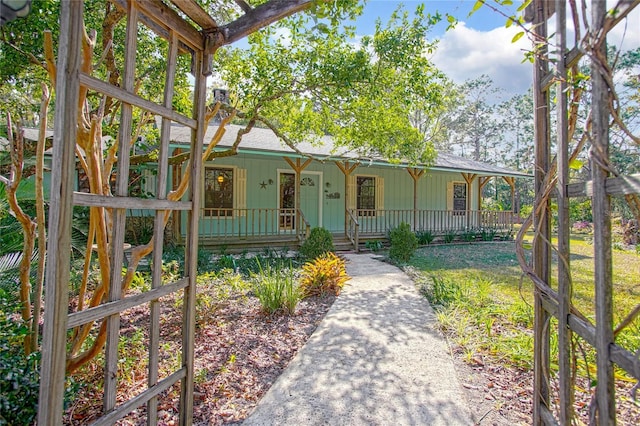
[[347, 175, 384, 216]]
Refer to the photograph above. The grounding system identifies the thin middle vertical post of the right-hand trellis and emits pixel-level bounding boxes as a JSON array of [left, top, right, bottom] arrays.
[[556, 0, 573, 425]]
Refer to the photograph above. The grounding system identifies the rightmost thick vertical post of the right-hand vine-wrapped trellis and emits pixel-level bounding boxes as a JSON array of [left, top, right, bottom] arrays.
[[591, 0, 616, 425]]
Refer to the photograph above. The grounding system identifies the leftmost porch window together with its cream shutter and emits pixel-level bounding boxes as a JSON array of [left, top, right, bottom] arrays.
[[203, 166, 247, 217]]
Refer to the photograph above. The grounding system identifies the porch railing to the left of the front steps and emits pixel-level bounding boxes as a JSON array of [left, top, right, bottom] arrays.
[[200, 208, 310, 241]]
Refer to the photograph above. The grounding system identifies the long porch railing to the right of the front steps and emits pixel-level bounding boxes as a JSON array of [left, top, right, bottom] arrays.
[[349, 209, 513, 236]]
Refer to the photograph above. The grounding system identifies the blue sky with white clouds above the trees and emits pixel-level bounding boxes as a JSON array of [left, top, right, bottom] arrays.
[[356, 0, 640, 98]]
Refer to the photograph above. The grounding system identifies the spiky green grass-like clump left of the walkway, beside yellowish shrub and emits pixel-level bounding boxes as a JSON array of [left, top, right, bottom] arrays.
[[253, 265, 300, 315]]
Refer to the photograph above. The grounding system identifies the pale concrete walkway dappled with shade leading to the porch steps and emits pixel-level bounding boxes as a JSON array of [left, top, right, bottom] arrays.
[[243, 254, 473, 426]]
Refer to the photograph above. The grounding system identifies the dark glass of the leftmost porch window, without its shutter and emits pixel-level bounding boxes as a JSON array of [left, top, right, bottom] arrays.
[[204, 167, 234, 216]]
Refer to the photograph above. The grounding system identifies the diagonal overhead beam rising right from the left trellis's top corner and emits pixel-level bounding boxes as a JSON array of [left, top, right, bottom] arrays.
[[222, 0, 313, 44]]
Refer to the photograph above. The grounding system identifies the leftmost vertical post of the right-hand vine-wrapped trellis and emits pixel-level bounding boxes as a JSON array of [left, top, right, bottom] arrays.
[[532, 0, 551, 426]]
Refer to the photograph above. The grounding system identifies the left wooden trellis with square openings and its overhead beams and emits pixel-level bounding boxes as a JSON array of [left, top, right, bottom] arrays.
[[38, 0, 324, 425]]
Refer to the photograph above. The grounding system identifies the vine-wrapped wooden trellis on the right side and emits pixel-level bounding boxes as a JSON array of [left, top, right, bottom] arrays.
[[518, 0, 640, 425]]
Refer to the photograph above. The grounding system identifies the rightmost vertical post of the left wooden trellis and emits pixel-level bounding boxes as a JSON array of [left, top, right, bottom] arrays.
[[180, 46, 207, 426]]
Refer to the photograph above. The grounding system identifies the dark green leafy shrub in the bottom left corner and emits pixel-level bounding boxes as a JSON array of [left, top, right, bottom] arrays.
[[0, 289, 40, 425]]
